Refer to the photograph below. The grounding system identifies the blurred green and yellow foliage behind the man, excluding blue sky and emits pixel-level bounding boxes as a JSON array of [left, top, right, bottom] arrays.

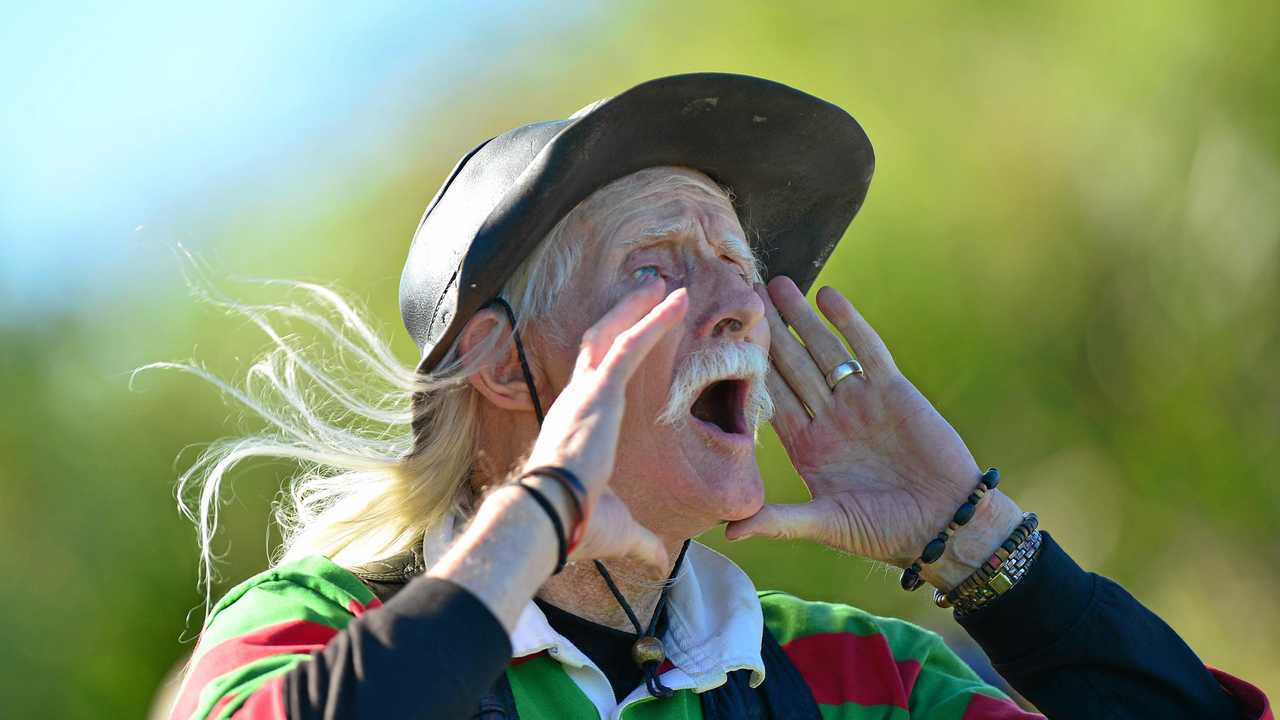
[[0, 1, 1280, 717]]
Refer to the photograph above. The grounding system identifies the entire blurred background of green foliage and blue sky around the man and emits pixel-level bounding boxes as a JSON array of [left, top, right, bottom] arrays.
[[0, 0, 1280, 717]]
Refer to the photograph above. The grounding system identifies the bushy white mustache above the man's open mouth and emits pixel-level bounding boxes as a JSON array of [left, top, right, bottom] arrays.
[[658, 342, 773, 434]]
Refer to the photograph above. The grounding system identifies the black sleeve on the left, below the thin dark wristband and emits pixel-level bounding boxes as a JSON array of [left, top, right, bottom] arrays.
[[283, 577, 511, 720]]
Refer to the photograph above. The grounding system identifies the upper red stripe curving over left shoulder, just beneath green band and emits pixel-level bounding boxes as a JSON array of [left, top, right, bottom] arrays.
[[172, 620, 338, 719]]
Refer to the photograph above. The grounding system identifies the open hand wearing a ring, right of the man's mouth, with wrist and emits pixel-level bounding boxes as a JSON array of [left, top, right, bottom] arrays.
[[726, 278, 1021, 588]]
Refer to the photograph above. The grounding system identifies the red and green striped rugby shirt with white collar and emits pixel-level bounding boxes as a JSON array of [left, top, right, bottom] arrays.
[[173, 530, 1271, 720]]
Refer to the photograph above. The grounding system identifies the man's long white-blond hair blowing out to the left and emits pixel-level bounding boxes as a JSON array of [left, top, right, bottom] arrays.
[[136, 168, 730, 607]]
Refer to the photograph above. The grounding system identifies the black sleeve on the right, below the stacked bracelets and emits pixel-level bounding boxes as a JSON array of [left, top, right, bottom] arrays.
[[959, 533, 1247, 720]]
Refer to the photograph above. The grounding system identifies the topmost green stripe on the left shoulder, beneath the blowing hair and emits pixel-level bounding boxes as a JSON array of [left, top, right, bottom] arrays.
[[197, 556, 374, 656]]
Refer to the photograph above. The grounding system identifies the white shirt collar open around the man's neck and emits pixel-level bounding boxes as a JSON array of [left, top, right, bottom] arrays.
[[511, 542, 764, 719]]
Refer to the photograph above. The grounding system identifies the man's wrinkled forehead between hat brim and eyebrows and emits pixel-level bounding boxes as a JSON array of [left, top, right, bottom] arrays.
[[579, 167, 751, 260]]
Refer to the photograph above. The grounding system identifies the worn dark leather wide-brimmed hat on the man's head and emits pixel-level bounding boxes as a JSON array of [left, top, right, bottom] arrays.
[[401, 73, 874, 373]]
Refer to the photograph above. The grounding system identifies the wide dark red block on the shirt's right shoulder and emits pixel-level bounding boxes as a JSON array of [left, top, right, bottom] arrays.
[[782, 633, 920, 710]]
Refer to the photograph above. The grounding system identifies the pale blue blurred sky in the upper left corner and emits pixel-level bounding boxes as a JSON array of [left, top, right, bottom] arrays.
[[0, 0, 588, 327]]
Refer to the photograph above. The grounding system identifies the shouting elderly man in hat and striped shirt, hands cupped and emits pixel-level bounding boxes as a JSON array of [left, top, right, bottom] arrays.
[[165, 74, 1271, 720]]
